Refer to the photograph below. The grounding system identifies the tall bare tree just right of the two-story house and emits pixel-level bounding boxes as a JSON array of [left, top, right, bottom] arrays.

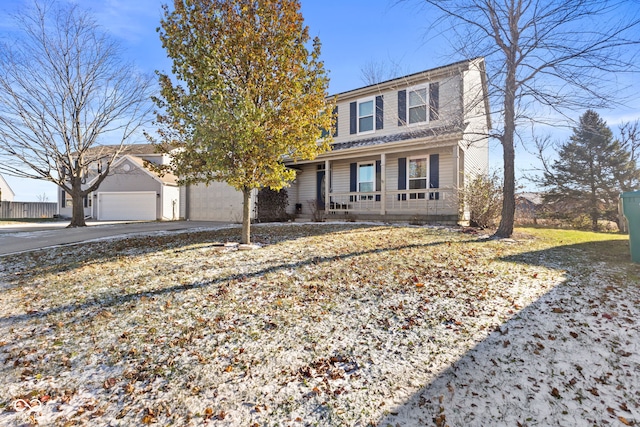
[[400, 0, 640, 237]]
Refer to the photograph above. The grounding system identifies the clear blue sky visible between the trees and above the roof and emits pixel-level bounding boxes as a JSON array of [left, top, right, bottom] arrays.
[[0, 0, 640, 201]]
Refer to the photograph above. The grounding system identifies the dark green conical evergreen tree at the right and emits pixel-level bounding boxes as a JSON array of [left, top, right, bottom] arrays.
[[543, 110, 636, 231]]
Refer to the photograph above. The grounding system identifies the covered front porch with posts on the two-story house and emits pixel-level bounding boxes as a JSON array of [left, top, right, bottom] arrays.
[[290, 144, 463, 223]]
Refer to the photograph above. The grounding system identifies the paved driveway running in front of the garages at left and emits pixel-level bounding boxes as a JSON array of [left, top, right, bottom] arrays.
[[0, 221, 234, 257]]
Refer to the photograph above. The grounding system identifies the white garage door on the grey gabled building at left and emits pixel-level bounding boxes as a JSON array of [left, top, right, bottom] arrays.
[[98, 191, 157, 221]]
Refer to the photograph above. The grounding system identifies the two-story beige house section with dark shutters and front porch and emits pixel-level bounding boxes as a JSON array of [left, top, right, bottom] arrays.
[[288, 58, 491, 222]]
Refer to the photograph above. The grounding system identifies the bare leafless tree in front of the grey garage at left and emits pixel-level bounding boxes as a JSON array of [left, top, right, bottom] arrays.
[[0, 2, 154, 227]]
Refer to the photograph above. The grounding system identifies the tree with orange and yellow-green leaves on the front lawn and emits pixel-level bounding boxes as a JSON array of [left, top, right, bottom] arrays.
[[155, 0, 333, 243]]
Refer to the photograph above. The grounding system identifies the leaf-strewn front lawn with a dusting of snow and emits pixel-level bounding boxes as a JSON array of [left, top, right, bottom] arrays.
[[0, 224, 640, 426]]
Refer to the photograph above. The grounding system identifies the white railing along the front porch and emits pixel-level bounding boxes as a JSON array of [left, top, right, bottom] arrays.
[[325, 188, 458, 215]]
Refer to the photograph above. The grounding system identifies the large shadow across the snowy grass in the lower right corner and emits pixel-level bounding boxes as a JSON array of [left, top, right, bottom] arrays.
[[375, 240, 640, 427]]
